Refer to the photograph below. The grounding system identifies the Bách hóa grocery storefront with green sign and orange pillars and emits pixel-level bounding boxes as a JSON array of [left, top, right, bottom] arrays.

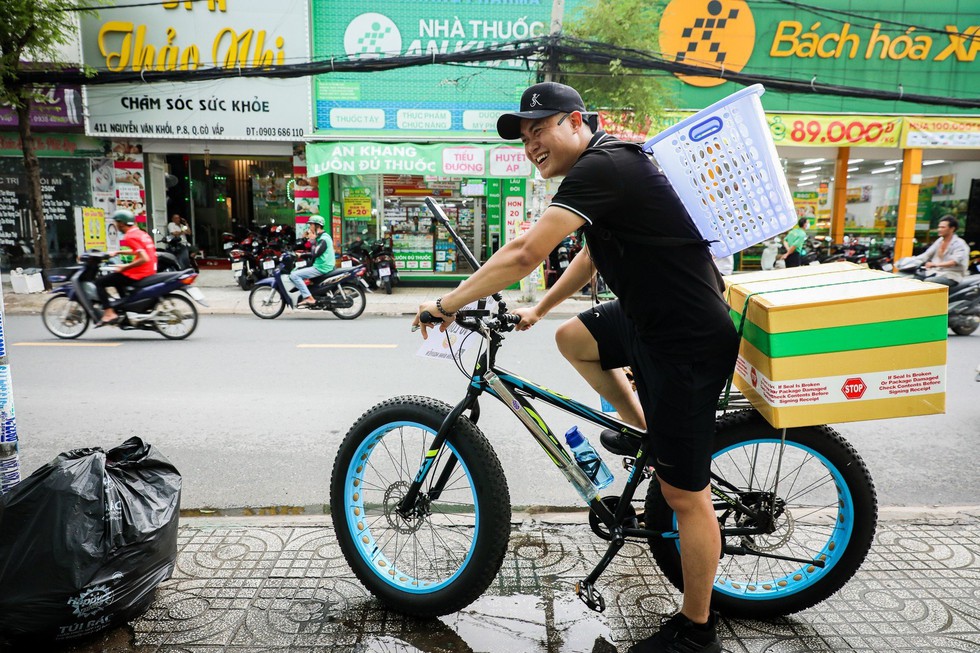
[[641, 0, 980, 267]]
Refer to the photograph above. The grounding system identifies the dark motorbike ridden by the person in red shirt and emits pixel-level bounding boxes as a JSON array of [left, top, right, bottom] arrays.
[[41, 252, 207, 340]]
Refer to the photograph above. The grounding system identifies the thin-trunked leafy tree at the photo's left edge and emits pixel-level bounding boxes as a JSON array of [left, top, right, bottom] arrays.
[[0, 0, 101, 288]]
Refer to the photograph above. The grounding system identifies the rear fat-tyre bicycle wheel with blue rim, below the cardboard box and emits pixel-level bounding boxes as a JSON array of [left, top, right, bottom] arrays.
[[646, 411, 878, 619]]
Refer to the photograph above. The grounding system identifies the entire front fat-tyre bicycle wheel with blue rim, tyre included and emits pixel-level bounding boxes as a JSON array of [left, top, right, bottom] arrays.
[[330, 396, 510, 618]]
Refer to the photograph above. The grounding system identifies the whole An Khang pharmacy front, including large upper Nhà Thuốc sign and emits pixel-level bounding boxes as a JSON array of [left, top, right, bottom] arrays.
[[307, 0, 551, 282]]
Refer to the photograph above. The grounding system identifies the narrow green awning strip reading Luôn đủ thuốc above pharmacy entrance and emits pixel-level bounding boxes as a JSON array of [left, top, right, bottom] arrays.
[[306, 141, 533, 178]]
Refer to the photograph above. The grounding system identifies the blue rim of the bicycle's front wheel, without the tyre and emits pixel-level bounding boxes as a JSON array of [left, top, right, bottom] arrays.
[[343, 422, 480, 594]]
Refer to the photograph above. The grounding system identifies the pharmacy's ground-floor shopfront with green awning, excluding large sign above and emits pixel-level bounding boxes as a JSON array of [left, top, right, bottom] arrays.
[[307, 142, 531, 279]]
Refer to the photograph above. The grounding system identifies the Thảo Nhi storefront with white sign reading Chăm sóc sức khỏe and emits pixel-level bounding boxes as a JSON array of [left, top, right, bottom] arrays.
[[81, 0, 312, 259]]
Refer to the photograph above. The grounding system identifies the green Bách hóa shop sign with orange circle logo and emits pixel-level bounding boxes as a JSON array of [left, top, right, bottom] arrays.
[[660, 0, 980, 114]]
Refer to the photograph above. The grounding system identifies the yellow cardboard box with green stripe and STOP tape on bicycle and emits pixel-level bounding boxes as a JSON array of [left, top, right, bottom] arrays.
[[725, 264, 947, 428]]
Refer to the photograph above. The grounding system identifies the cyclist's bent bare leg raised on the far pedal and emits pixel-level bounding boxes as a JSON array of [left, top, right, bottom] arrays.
[[555, 317, 646, 429]]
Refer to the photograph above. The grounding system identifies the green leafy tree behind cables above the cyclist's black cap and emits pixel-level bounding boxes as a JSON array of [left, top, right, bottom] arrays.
[[559, 0, 670, 132]]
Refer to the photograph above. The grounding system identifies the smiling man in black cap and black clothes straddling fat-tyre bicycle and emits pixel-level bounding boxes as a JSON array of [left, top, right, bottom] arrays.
[[413, 82, 738, 653]]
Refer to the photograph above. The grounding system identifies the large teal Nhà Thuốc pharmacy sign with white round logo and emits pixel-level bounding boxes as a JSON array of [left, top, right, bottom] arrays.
[[311, 0, 552, 140]]
